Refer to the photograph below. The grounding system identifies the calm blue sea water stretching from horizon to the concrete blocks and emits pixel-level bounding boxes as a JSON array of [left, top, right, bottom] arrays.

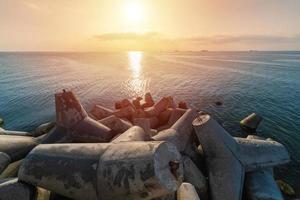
[[0, 52, 300, 192]]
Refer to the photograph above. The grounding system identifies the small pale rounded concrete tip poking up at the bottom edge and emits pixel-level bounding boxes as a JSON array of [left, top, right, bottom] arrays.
[[177, 183, 200, 200]]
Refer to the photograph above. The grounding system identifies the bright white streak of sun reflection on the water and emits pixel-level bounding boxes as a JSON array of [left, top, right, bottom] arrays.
[[128, 51, 146, 96]]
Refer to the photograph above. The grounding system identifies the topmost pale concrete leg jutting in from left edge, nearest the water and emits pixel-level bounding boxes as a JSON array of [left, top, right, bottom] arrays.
[[0, 135, 37, 162]]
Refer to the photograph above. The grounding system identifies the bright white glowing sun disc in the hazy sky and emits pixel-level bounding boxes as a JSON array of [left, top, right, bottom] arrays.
[[124, 1, 143, 23]]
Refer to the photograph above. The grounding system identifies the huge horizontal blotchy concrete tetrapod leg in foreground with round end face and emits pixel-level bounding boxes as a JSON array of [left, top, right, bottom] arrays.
[[19, 141, 183, 200]]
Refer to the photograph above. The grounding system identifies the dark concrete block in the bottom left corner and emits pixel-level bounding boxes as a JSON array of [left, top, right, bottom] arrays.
[[0, 178, 36, 200]]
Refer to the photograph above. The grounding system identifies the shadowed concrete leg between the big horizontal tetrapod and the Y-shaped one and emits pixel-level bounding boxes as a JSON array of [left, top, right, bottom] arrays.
[[182, 156, 208, 200]]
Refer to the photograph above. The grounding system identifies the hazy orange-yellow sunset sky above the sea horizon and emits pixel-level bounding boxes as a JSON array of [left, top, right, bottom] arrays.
[[0, 0, 300, 51]]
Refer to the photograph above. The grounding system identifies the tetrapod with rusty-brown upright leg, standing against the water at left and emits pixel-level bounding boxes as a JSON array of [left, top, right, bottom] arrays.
[[55, 90, 114, 142]]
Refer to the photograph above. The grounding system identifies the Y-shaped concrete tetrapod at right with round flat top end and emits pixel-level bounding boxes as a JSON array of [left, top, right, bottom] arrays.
[[193, 114, 289, 200]]
